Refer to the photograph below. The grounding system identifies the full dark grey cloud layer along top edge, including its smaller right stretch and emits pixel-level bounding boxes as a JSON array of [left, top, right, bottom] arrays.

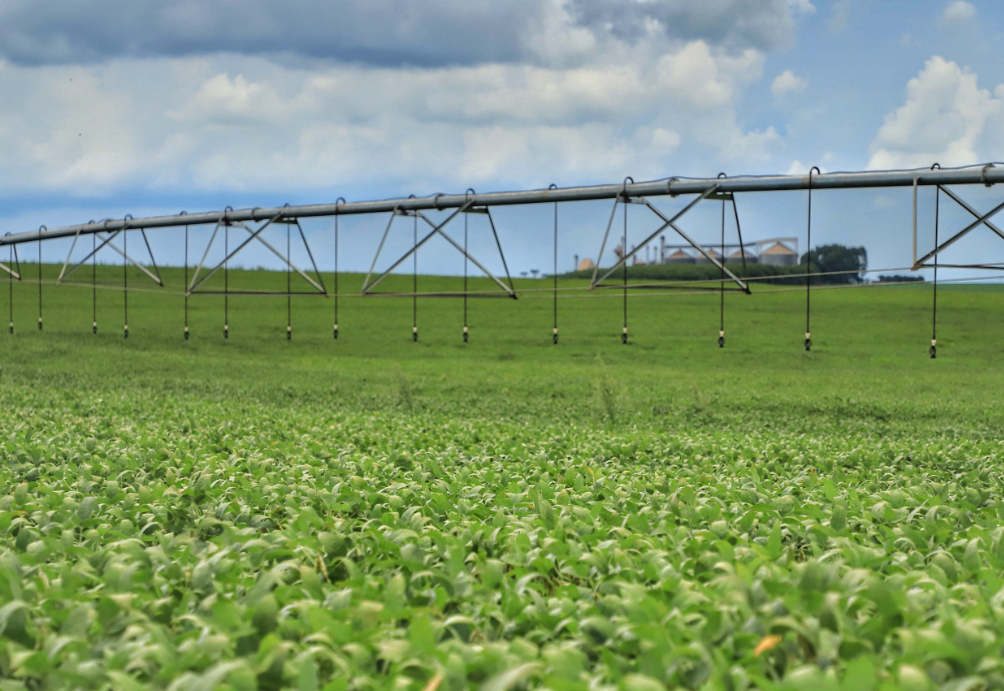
[[0, 0, 806, 66]]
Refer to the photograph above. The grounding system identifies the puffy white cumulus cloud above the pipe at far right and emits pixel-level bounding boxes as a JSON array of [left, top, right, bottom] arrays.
[[868, 55, 1002, 170]]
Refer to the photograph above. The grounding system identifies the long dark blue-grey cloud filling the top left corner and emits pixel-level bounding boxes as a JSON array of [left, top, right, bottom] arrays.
[[0, 0, 539, 65]]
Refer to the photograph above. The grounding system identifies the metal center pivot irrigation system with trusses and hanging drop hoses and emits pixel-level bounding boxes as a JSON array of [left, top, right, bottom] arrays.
[[0, 164, 1004, 358]]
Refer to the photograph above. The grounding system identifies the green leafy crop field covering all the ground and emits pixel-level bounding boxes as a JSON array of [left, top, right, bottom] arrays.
[[0, 266, 1004, 691]]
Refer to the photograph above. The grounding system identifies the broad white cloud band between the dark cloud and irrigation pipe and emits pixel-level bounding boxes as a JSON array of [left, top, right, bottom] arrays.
[[0, 41, 779, 196]]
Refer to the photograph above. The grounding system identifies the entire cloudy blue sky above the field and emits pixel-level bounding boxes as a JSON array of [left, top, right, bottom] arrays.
[[0, 0, 1004, 277]]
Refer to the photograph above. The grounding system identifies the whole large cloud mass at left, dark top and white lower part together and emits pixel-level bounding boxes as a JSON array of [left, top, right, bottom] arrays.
[[0, 0, 815, 202]]
